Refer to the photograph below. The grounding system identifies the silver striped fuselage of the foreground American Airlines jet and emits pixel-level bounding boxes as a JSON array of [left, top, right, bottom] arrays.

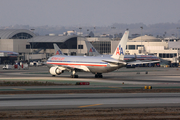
[[47, 55, 125, 74]]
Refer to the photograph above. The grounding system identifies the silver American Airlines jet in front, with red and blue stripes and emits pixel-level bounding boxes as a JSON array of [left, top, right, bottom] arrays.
[[46, 30, 145, 78]]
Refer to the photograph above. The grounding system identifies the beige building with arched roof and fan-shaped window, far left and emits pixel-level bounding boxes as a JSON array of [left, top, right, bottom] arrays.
[[0, 29, 35, 64]]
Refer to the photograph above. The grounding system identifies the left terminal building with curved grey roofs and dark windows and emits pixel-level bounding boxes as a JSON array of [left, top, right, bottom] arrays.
[[0, 29, 87, 64]]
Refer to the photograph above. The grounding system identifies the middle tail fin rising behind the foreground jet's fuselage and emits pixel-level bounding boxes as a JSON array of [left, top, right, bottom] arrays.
[[85, 41, 100, 56]]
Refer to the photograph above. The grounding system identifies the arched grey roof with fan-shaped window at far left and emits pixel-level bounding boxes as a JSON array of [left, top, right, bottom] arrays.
[[0, 29, 35, 39]]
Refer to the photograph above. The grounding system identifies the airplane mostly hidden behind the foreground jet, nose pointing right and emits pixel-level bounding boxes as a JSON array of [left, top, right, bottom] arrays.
[[85, 41, 160, 65]]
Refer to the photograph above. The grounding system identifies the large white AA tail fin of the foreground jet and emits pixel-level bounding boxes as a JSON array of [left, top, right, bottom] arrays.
[[111, 30, 129, 60]]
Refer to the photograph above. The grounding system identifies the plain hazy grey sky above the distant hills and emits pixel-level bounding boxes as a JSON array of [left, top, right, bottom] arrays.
[[0, 0, 180, 26]]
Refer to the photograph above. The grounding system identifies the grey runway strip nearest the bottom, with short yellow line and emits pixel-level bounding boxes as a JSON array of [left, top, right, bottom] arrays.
[[0, 93, 180, 110]]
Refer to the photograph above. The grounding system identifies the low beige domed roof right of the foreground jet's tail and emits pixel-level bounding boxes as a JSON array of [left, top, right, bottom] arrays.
[[129, 35, 162, 42]]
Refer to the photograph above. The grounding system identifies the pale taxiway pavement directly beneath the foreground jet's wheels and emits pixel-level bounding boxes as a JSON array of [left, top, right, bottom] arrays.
[[0, 66, 180, 85]]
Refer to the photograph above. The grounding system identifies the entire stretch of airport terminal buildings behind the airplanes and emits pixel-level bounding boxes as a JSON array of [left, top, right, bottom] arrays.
[[0, 29, 180, 64]]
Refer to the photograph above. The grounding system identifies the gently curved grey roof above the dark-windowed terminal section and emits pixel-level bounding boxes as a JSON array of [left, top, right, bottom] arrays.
[[28, 35, 77, 43]]
